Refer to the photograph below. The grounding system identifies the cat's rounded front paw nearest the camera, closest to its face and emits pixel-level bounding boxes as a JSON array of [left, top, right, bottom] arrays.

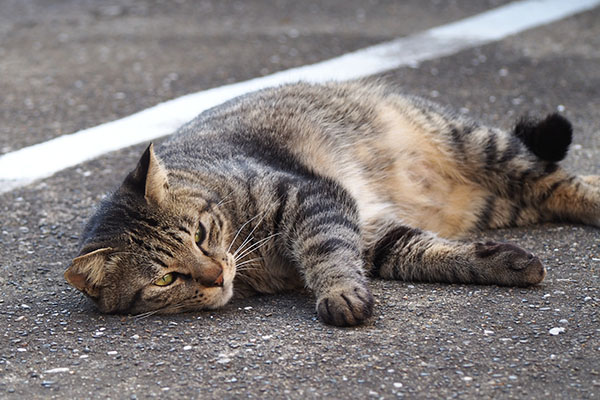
[[317, 286, 373, 326]]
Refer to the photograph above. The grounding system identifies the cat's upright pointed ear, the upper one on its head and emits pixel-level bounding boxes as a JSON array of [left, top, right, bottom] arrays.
[[125, 143, 169, 204]]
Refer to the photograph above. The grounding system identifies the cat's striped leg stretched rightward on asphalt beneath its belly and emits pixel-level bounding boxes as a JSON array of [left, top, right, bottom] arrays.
[[366, 222, 546, 286]]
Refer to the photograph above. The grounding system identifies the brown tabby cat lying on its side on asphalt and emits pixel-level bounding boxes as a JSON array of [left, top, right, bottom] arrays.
[[65, 81, 600, 326]]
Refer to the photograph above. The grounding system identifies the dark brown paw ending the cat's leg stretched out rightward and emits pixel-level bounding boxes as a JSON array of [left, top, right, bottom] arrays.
[[475, 242, 546, 286]]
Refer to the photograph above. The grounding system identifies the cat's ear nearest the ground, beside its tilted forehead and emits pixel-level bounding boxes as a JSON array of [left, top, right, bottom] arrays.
[[65, 248, 112, 298]]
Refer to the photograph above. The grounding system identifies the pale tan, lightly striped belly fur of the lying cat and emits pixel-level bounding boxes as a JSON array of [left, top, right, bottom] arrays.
[[340, 104, 490, 238]]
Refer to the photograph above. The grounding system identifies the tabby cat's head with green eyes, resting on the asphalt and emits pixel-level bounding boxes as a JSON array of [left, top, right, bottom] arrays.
[[65, 144, 235, 314]]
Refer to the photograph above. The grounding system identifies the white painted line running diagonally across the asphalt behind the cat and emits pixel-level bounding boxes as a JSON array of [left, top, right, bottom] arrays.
[[0, 0, 600, 193]]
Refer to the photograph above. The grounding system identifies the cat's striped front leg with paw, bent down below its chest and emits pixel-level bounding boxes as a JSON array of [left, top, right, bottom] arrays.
[[276, 182, 373, 326]]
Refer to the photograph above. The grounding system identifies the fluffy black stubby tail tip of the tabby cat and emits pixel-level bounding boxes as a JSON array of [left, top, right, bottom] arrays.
[[514, 113, 573, 162]]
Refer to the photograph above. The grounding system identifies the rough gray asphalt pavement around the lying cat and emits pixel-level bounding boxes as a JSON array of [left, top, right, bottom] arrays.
[[0, 0, 600, 399]]
